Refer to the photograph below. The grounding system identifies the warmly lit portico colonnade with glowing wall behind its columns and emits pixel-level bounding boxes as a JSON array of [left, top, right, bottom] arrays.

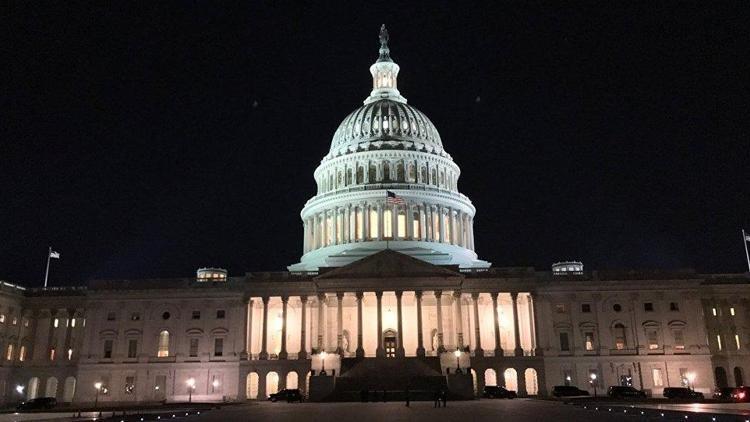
[[245, 290, 541, 359]]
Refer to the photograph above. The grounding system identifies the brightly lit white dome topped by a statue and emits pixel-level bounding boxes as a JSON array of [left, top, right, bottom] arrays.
[[289, 26, 490, 271]]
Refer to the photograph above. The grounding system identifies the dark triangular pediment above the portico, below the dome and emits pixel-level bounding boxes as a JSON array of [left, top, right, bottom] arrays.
[[316, 249, 463, 280]]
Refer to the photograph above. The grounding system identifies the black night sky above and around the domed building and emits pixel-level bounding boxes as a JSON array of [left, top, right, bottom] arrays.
[[5, 1, 750, 285]]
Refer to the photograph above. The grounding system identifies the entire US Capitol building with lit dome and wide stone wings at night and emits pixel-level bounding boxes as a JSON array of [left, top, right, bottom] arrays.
[[0, 29, 750, 403]]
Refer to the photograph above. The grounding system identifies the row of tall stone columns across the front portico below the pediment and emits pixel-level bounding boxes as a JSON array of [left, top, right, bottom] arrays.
[[245, 290, 542, 359]]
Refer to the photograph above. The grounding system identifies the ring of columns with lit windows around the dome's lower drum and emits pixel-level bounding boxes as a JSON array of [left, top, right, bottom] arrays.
[[303, 202, 474, 253]]
